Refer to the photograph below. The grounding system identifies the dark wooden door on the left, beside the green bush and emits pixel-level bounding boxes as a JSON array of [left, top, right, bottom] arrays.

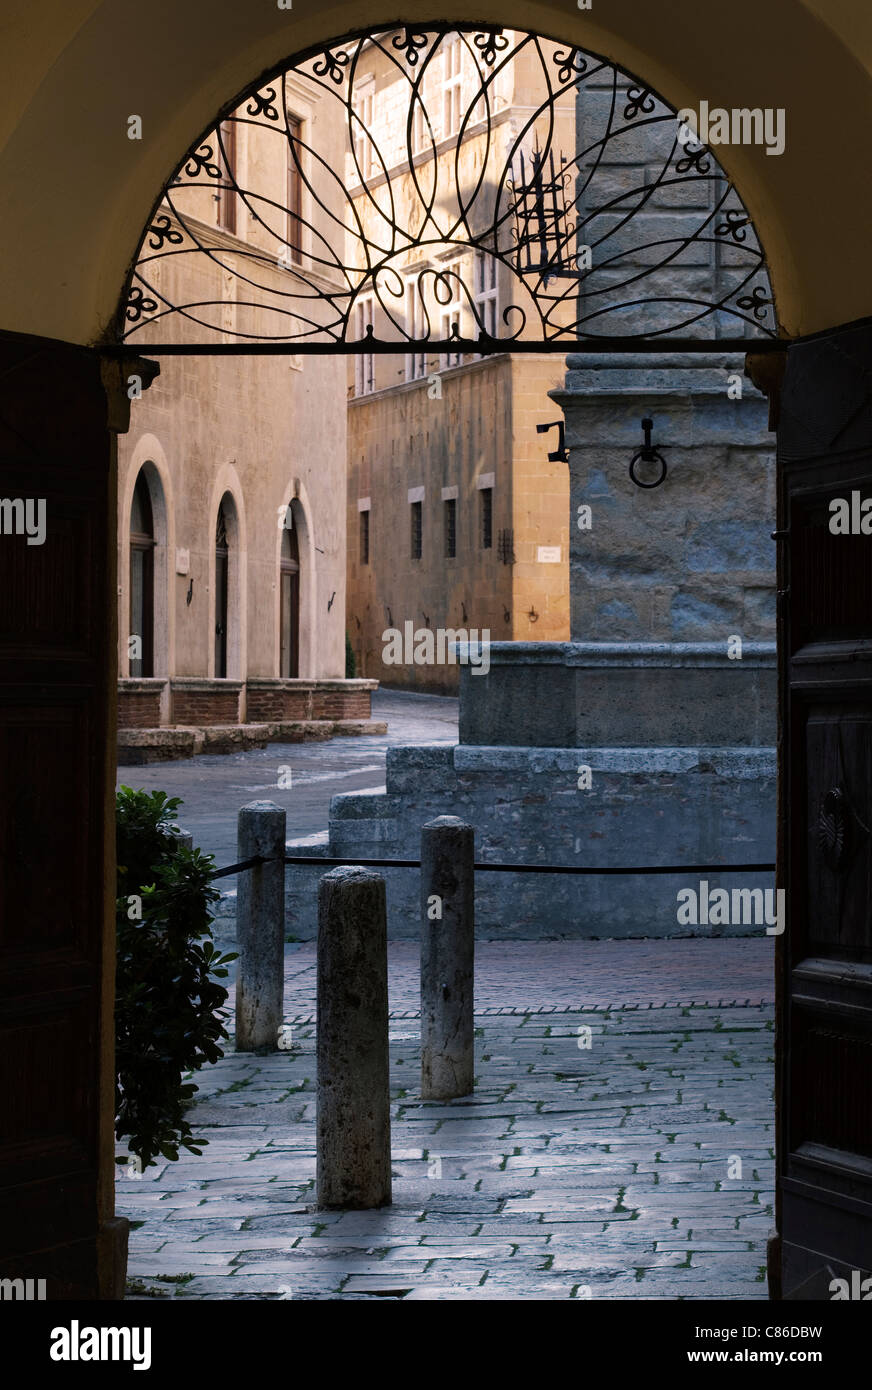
[[0, 334, 115, 1298]]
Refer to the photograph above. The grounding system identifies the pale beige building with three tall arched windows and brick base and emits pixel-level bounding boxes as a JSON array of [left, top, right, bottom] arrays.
[[118, 78, 374, 762]]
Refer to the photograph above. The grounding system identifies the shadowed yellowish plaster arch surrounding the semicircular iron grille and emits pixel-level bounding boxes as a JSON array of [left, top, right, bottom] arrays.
[[0, 0, 872, 342]]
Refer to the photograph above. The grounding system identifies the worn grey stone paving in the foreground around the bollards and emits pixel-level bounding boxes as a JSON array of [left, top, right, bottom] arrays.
[[117, 941, 775, 1301]]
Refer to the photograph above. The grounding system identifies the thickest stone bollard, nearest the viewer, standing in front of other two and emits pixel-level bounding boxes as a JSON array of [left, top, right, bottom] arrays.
[[317, 867, 391, 1209]]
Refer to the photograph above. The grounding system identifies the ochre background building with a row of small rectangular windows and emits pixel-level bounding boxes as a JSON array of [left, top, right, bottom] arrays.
[[348, 33, 574, 692]]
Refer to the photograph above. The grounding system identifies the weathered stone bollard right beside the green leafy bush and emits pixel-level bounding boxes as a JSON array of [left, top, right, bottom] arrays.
[[236, 801, 285, 1052]]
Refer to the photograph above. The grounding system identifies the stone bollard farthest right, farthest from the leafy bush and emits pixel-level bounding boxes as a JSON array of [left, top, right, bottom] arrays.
[[421, 816, 476, 1101]]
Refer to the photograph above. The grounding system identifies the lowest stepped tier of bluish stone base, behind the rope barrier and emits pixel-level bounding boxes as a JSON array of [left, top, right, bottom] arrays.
[[279, 745, 776, 940]]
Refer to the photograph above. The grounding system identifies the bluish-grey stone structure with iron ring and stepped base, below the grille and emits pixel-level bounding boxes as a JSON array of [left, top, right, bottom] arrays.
[[273, 354, 776, 938]]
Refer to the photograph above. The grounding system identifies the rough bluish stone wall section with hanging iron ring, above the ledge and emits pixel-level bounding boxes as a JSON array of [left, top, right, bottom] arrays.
[[552, 354, 775, 646]]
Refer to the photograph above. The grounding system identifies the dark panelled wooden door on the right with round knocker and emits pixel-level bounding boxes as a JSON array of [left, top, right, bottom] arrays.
[[773, 325, 872, 1300]]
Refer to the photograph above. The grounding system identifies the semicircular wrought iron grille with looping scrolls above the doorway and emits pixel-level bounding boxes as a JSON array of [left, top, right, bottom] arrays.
[[117, 25, 777, 353]]
